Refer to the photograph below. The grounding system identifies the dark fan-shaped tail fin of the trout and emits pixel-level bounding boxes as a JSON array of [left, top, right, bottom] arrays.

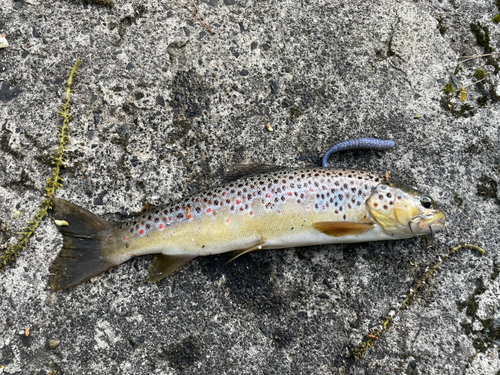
[[50, 198, 117, 290]]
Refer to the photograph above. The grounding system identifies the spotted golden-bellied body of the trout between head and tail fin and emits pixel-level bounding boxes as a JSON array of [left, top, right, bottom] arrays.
[[110, 168, 388, 255]]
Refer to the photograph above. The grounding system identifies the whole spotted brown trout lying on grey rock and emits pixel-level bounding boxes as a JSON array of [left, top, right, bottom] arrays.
[[49, 165, 445, 290]]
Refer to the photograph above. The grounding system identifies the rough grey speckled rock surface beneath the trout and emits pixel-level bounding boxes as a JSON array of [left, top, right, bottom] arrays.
[[0, 0, 500, 375]]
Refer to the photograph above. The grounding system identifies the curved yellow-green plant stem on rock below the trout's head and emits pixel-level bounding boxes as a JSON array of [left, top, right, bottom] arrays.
[[353, 243, 486, 360]]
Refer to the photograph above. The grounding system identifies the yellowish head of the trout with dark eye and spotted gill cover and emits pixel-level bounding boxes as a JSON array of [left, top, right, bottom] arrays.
[[366, 180, 445, 238]]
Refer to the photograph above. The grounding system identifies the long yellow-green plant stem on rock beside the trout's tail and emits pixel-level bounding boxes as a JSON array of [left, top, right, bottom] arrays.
[[0, 58, 82, 271]]
